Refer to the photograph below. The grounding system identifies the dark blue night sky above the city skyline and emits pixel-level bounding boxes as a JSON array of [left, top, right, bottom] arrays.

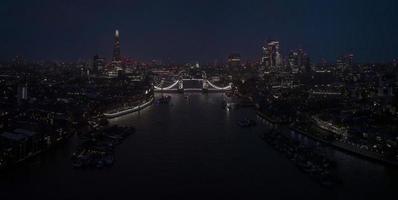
[[0, 0, 398, 62]]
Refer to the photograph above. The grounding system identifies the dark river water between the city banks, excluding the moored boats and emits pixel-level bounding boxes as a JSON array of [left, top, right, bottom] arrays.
[[0, 93, 398, 199]]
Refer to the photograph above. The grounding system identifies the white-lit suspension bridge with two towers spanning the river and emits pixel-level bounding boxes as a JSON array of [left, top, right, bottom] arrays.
[[154, 71, 232, 92]]
